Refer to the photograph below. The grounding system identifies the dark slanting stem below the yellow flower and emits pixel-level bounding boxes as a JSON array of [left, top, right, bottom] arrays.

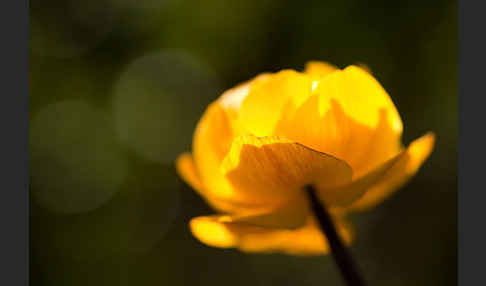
[[305, 185, 365, 286]]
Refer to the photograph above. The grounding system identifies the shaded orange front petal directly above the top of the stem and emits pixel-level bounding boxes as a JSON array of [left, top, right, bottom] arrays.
[[221, 135, 352, 205]]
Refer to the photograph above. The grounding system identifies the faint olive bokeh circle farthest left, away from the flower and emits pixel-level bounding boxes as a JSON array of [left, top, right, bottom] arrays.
[[30, 100, 127, 213]]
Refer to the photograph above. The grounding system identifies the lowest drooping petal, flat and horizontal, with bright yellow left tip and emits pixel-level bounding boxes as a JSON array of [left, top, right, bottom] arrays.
[[190, 216, 353, 255]]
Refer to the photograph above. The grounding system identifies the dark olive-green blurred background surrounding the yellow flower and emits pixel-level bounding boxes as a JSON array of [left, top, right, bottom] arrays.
[[30, 0, 457, 286]]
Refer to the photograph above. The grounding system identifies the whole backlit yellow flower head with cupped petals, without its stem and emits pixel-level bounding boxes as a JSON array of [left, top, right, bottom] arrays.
[[177, 62, 434, 255]]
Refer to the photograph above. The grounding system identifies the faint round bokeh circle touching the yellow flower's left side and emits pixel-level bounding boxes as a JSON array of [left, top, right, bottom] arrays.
[[113, 51, 221, 164]]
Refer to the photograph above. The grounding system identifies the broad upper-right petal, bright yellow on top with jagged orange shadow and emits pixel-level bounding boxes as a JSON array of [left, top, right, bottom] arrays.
[[275, 66, 402, 176]]
